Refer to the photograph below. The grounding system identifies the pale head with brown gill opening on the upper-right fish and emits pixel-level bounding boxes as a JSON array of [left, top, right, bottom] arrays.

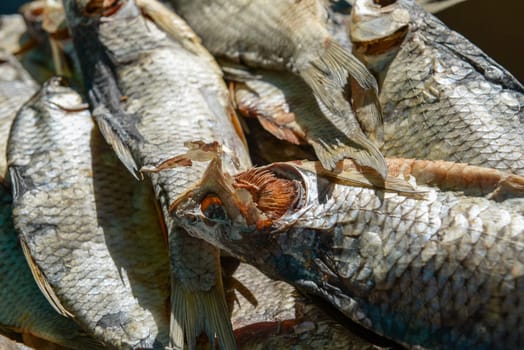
[[350, 0, 410, 80]]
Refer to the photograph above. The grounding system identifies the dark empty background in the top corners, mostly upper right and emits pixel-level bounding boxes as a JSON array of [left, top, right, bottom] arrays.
[[0, 0, 524, 82]]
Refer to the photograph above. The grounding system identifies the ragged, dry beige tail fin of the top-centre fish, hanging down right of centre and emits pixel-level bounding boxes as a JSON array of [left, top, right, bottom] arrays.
[[299, 41, 387, 178]]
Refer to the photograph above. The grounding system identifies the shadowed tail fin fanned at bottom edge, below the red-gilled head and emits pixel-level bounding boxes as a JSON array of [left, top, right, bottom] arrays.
[[170, 278, 237, 350]]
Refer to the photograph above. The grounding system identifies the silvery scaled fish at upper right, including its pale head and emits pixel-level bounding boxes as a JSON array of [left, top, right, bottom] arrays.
[[350, 0, 524, 175]]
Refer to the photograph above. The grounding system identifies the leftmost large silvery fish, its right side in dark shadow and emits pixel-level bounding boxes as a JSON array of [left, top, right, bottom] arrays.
[[8, 78, 169, 349]]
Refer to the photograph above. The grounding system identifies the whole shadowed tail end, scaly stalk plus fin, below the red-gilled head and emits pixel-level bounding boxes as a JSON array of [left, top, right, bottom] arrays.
[[170, 228, 237, 350]]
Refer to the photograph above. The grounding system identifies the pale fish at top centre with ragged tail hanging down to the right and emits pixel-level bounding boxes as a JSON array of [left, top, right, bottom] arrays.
[[171, 0, 386, 177]]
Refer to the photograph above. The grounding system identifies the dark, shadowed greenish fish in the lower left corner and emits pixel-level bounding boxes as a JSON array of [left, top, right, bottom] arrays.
[[0, 185, 103, 350]]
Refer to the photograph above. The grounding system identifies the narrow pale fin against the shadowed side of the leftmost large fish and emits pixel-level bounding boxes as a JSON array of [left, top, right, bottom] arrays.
[[93, 105, 140, 180]]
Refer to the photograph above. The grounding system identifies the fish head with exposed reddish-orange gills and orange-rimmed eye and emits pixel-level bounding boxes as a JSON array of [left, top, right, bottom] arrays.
[[171, 158, 306, 257]]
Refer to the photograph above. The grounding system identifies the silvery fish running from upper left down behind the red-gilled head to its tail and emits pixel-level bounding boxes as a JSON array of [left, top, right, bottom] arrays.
[[65, 0, 250, 349]]
